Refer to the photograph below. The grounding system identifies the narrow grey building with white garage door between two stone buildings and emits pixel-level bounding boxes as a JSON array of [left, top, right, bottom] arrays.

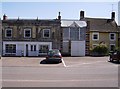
[[61, 20, 87, 56]]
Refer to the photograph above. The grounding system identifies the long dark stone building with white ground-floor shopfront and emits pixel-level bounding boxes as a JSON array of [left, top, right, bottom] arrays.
[[2, 14, 61, 56]]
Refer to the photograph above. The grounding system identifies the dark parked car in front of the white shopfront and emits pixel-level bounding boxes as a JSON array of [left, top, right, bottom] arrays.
[[46, 49, 62, 63]]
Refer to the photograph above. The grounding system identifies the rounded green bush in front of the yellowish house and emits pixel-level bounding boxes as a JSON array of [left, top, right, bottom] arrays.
[[91, 44, 108, 56]]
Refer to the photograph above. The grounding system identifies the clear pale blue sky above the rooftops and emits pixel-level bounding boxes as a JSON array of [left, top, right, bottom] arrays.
[[0, 0, 118, 22]]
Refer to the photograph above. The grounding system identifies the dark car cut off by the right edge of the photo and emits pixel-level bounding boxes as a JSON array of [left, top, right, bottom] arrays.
[[109, 51, 120, 62]]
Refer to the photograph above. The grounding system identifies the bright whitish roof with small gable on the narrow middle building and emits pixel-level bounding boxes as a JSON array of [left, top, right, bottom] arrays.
[[61, 20, 87, 27]]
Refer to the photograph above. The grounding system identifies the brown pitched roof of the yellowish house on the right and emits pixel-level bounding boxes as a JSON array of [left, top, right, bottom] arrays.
[[84, 18, 119, 32]]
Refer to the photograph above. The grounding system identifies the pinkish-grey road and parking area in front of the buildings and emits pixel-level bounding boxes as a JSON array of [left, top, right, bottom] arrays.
[[2, 57, 119, 87]]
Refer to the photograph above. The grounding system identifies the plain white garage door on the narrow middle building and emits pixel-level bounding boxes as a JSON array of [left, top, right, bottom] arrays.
[[71, 41, 85, 56]]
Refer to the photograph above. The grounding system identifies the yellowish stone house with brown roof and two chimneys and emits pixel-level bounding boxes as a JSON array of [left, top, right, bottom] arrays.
[[80, 11, 119, 55]]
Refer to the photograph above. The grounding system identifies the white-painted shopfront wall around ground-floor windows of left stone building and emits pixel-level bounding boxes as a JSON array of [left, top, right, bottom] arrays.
[[3, 41, 52, 56]]
